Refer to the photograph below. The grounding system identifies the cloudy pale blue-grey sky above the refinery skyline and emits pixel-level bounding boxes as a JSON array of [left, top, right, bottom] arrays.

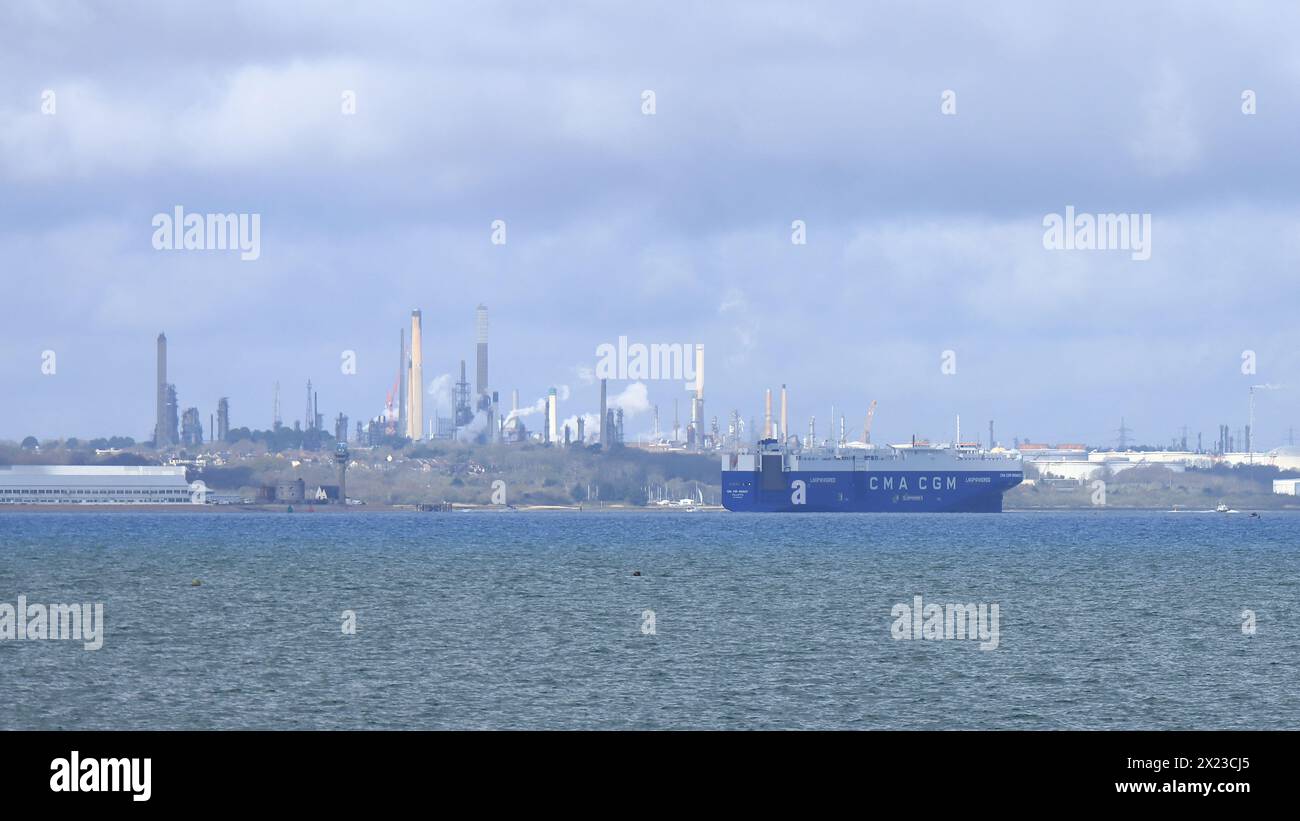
[[0, 1, 1300, 448]]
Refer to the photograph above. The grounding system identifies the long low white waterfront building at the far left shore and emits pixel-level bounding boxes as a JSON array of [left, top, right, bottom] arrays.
[[0, 465, 208, 504]]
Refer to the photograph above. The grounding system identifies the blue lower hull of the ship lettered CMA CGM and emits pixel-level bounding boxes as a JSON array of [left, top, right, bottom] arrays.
[[723, 465, 1024, 513]]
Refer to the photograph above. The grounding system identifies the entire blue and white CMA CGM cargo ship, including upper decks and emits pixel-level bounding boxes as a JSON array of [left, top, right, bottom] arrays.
[[722, 439, 1024, 513]]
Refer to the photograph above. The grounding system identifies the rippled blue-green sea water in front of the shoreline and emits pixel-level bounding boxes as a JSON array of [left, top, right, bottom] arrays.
[[0, 511, 1300, 729]]
